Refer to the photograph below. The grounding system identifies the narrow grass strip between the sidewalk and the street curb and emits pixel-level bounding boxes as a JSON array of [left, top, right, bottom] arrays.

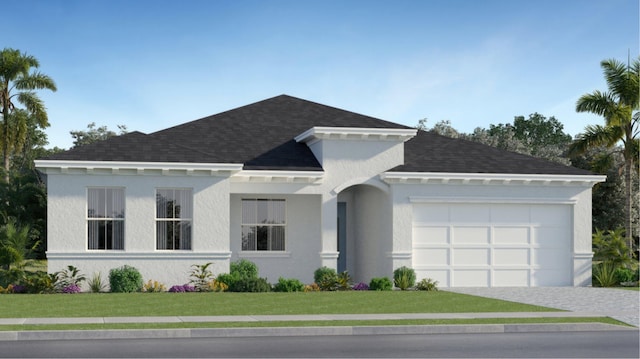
[[0, 317, 629, 331]]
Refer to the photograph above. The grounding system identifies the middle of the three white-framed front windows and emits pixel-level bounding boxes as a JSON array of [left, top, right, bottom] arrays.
[[156, 189, 193, 250]]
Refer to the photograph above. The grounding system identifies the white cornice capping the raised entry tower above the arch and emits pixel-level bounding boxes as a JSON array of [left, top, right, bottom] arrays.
[[294, 127, 418, 144]]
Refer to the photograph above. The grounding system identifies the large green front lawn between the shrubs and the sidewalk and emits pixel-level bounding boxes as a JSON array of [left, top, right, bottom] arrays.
[[0, 291, 558, 318]]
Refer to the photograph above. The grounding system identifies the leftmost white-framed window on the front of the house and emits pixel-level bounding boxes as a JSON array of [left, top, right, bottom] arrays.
[[87, 188, 124, 249]]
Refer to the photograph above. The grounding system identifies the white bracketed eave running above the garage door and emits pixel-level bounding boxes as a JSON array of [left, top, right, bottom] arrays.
[[380, 172, 607, 187]]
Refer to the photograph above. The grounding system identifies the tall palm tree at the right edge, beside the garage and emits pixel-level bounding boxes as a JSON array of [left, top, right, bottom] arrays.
[[569, 59, 640, 255]]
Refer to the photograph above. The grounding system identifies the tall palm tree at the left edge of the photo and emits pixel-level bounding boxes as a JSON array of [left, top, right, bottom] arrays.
[[0, 48, 56, 182]]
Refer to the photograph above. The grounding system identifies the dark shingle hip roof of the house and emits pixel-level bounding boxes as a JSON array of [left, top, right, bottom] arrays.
[[47, 95, 590, 175]]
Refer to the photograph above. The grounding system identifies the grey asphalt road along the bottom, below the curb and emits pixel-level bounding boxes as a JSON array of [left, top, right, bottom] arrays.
[[0, 331, 640, 358]]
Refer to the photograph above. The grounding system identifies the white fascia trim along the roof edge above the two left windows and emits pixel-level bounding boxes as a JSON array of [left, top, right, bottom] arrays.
[[34, 160, 243, 175]]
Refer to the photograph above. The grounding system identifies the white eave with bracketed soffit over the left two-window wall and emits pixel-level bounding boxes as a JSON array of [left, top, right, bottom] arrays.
[[35, 160, 243, 177]]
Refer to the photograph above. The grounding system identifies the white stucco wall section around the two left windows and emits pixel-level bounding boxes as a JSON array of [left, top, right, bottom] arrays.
[[47, 174, 235, 286]]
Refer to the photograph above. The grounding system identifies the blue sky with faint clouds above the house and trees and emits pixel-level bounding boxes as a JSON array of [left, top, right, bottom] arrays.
[[3, 0, 640, 148]]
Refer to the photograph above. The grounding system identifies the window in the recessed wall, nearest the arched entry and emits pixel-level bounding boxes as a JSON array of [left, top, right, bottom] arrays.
[[242, 199, 286, 251]]
